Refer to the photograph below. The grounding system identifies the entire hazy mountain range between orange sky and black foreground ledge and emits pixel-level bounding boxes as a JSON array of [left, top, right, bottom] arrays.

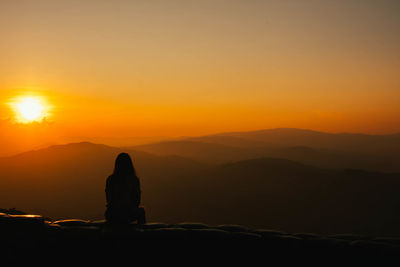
[[0, 129, 400, 236]]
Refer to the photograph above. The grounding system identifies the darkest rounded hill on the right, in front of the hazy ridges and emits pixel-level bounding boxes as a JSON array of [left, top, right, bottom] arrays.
[[165, 158, 400, 236]]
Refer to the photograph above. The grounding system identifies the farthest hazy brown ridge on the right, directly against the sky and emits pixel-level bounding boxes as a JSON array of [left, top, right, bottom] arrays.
[[132, 129, 400, 172]]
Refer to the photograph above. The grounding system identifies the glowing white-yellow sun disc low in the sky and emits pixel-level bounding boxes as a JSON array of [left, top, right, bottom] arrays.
[[13, 96, 47, 123]]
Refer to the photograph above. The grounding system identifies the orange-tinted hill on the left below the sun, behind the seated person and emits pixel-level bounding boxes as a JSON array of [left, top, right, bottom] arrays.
[[0, 142, 206, 219]]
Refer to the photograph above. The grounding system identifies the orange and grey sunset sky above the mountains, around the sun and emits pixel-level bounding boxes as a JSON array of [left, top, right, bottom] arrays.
[[0, 0, 400, 156]]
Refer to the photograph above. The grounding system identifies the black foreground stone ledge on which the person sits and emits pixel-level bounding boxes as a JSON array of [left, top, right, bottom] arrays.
[[0, 213, 400, 266]]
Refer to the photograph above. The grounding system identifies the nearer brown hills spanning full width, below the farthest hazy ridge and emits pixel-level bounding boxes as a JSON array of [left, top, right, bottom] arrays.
[[0, 143, 400, 236]]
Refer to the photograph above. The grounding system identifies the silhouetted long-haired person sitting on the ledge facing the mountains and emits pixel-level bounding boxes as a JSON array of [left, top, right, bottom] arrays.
[[104, 153, 146, 224]]
